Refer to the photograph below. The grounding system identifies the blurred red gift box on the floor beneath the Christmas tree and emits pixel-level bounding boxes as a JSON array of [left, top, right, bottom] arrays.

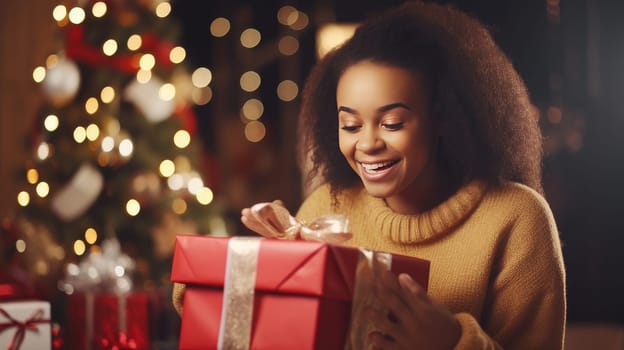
[[67, 293, 149, 350]]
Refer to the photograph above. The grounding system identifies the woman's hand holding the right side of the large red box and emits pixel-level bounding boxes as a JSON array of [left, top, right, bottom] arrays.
[[366, 269, 461, 350]]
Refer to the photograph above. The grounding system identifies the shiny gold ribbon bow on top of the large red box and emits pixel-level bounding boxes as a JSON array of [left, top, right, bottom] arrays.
[[251, 202, 353, 244]]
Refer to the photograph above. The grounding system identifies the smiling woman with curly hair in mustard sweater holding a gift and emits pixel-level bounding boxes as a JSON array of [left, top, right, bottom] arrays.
[[241, 1, 566, 349]]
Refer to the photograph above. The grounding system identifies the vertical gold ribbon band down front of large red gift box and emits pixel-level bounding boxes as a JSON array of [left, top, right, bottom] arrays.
[[217, 237, 261, 350]]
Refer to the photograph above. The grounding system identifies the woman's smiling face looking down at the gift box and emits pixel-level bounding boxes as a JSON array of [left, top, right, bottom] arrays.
[[336, 61, 436, 214]]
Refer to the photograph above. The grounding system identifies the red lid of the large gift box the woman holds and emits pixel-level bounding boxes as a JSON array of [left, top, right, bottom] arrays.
[[171, 235, 429, 300]]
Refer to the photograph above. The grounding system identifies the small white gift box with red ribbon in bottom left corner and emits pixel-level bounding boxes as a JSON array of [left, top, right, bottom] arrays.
[[0, 300, 52, 350]]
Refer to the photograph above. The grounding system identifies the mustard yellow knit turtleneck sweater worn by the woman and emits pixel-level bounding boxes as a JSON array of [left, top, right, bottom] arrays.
[[297, 181, 566, 350]]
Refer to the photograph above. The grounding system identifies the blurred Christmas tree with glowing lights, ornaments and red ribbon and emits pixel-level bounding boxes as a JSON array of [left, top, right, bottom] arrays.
[[16, 0, 227, 285]]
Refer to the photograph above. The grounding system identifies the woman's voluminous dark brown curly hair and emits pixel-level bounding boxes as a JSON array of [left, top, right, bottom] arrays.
[[299, 1, 543, 195]]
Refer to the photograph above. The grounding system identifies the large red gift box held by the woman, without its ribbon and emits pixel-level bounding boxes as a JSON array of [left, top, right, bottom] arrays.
[[171, 235, 429, 350]]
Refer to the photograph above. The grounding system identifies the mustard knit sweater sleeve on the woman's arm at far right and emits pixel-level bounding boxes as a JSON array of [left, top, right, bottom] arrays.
[[456, 187, 566, 350]]
